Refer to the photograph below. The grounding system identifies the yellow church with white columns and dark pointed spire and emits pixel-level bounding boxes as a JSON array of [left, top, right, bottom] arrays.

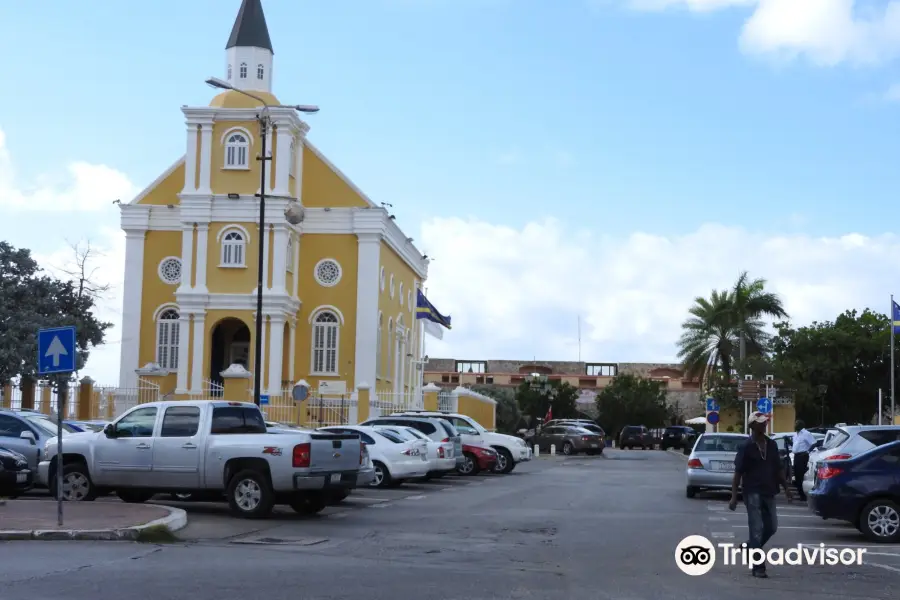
[[120, 0, 428, 422]]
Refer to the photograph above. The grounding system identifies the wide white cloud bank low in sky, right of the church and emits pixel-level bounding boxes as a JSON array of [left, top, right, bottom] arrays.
[[421, 219, 900, 362]]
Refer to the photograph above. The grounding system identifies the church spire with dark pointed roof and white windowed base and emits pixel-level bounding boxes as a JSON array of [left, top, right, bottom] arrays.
[[225, 0, 274, 93]]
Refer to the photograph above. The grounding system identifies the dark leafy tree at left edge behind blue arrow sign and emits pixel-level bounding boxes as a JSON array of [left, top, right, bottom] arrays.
[[0, 241, 112, 382]]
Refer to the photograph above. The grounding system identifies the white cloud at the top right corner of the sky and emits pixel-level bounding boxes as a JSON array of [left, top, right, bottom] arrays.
[[626, 0, 900, 66]]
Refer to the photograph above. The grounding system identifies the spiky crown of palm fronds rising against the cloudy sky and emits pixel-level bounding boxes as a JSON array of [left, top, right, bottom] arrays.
[[678, 271, 787, 388]]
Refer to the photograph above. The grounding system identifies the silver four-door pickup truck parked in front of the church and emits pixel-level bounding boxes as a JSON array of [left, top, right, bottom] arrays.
[[38, 401, 365, 518]]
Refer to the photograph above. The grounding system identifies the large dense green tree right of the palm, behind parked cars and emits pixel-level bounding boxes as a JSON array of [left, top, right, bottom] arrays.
[[772, 309, 891, 424]]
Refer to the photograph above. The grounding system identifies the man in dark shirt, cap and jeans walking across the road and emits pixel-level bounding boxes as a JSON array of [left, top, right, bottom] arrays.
[[728, 412, 791, 577]]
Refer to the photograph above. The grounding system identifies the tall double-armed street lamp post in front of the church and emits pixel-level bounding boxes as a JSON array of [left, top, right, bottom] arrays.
[[206, 77, 319, 406]]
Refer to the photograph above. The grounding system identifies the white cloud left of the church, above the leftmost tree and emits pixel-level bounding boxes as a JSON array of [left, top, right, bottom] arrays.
[[0, 130, 138, 211]]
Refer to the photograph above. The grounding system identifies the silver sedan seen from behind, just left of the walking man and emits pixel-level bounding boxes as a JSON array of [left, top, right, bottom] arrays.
[[685, 433, 750, 498]]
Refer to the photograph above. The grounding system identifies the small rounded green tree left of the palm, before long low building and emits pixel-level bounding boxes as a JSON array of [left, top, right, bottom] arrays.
[[597, 375, 673, 437]]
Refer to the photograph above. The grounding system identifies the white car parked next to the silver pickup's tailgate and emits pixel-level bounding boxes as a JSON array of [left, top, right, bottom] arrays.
[[321, 425, 429, 487]]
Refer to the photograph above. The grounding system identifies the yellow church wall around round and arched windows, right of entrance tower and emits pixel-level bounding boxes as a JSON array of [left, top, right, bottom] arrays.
[[285, 234, 358, 390]]
